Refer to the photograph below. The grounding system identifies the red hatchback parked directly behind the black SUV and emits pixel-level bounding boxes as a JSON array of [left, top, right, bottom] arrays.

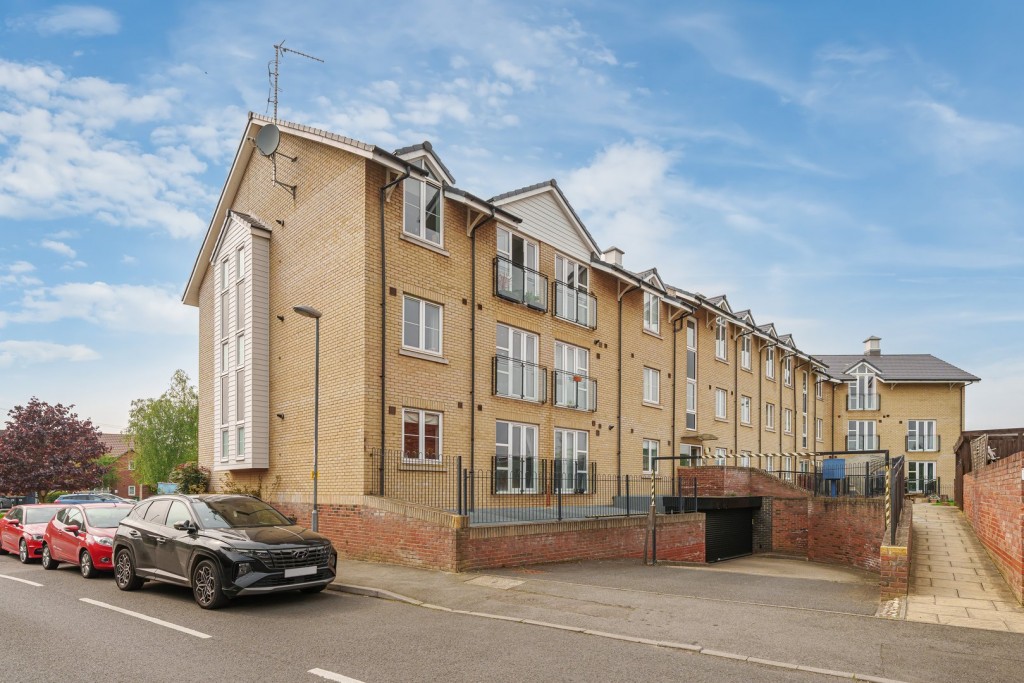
[[42, 503, 134, 579]]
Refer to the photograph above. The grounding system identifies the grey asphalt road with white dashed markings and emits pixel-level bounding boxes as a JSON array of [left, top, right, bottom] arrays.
[[0, 557, 835, 683]]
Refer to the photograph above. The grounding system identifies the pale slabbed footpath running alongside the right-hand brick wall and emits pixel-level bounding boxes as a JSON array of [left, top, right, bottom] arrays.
[[906, 503, 1024, 633]]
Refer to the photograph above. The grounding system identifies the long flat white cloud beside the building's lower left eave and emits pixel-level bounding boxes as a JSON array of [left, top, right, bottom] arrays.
[[8, 282, 196, 335]]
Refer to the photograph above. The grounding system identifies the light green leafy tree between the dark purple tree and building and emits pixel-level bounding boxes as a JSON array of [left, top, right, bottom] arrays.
[[124, 370, 199, 487]]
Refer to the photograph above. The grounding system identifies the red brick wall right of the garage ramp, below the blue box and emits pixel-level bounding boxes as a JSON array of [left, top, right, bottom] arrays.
[[807, 498, 886, 572]]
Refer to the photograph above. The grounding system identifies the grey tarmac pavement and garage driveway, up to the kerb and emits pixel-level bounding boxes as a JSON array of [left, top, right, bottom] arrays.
[[332, 552, 1024, 683]]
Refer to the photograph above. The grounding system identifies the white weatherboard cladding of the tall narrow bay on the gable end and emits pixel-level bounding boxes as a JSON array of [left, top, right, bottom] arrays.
[[208, 216, 270, 470]]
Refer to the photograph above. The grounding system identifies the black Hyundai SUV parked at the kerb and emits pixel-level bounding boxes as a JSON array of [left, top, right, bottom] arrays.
[[114, 494, 338, 609]]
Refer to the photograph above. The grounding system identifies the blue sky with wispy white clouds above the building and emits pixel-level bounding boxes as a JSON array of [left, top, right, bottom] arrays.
[[0, 0, 1024, 431]]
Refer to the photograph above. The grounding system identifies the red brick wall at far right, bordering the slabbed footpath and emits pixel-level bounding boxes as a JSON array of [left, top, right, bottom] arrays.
[[964, 453, 1024, 603]]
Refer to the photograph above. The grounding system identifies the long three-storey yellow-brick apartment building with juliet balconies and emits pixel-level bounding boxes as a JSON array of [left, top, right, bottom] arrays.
[[183, 115, 977, 528]]
